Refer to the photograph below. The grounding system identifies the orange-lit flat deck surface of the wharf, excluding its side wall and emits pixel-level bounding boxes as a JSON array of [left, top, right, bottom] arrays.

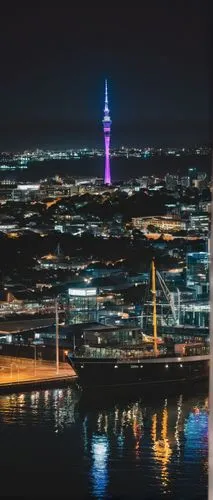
[[0, 356, 75, 385]]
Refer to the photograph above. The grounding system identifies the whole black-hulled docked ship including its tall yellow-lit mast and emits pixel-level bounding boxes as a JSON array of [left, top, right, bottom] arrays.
[[67, 260, 210, 388]]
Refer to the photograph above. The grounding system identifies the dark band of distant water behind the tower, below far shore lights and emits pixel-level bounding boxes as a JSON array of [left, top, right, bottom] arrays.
[[0, 155, 211, 182]]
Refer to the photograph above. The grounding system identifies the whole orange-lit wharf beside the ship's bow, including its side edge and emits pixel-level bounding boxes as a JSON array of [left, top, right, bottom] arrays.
[[0, 356, 76, 394]]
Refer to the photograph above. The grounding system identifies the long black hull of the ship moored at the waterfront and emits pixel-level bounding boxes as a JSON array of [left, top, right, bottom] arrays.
[[68, 355, 209, 388]]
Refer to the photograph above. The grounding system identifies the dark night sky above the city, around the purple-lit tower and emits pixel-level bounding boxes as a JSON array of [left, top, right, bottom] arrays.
[[0, 0, 209, 151]]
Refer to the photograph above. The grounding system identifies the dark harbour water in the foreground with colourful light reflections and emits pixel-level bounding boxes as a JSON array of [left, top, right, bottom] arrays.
[[0, 387, 208, 500]]
